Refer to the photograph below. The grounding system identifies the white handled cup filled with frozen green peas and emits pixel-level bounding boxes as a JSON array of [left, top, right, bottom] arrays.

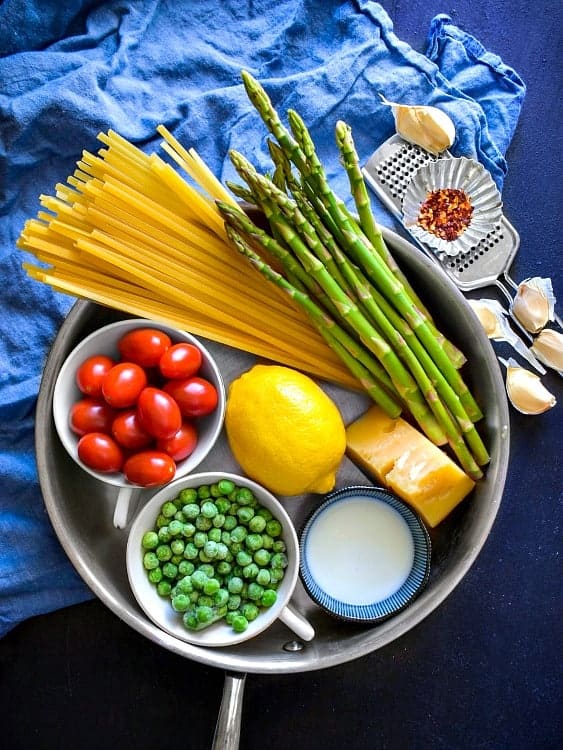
[[127, 472, 314, 647]]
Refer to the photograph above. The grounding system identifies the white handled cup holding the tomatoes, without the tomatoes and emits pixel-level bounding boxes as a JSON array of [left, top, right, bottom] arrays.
[[53, 318, 226, 528]]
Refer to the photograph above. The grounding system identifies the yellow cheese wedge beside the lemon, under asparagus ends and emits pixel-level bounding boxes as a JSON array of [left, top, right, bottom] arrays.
[[346, 406, 475, 527]]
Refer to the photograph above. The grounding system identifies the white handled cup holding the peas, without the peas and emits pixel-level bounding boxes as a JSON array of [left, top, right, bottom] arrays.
[[126, 472, 315, 646]]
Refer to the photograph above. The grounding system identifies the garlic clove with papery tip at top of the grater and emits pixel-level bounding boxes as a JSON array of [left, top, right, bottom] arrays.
[[380, 94, 455, 155]]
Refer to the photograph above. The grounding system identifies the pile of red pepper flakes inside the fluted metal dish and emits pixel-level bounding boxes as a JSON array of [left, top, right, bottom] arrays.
[[417, 188, 473, 241]]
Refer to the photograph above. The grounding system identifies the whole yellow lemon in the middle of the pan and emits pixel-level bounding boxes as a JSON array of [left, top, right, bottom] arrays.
[[225, 365, 346, 495]]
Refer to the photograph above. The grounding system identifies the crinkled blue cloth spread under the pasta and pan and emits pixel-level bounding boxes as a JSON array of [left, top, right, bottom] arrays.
[[0, 0, 525, 635]]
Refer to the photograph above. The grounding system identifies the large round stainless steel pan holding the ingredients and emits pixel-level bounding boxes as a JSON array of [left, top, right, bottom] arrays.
[[36, 229, 509, 748]]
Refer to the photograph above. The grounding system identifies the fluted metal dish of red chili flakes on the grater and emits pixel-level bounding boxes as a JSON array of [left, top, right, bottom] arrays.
[[402, 156, 502, 256]]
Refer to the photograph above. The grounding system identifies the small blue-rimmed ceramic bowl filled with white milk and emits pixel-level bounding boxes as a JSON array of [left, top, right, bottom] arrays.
[[299, 486, 431, 623]]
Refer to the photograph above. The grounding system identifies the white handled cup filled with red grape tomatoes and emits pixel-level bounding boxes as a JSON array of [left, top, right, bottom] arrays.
[[53, 318, 226, 528]]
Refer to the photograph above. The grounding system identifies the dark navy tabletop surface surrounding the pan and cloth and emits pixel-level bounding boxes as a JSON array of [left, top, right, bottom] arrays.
[[0, 0, 563, 750]]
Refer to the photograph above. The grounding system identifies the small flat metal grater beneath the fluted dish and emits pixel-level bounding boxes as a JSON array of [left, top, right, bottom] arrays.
[[362, 135, 520, 304]]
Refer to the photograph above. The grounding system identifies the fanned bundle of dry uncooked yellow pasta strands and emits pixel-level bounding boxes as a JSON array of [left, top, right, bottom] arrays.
[[17, 126, 359, 388]]
